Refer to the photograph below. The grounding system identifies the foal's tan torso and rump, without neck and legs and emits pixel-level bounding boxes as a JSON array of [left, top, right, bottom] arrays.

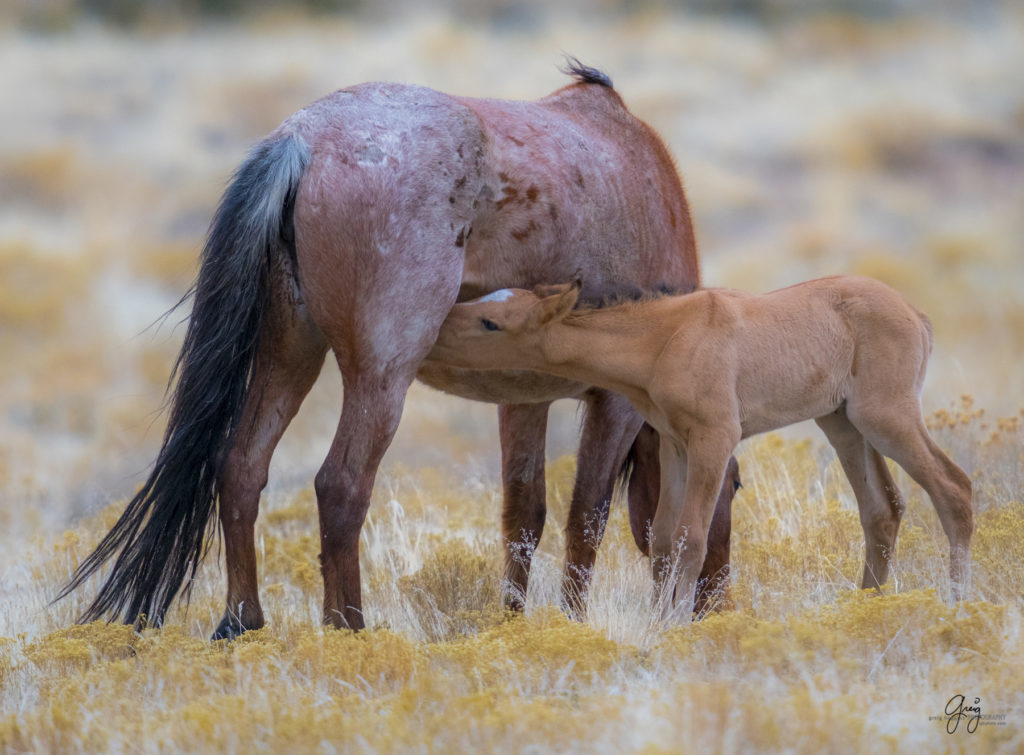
[[667, 276, 931, 437]]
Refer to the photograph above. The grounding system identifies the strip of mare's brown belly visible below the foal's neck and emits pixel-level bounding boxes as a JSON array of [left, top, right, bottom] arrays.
[[416, 362, 588, 404]]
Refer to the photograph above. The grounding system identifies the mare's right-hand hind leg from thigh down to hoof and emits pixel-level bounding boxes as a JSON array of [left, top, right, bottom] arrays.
[[296, 258, 461, 629]]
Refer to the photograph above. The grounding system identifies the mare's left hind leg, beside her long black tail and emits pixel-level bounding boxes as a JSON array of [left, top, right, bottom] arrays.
[[213, 276, 327, 639]]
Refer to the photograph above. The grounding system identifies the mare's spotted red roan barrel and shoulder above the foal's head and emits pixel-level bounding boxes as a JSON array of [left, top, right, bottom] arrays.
[[459, 84, 698, 289]]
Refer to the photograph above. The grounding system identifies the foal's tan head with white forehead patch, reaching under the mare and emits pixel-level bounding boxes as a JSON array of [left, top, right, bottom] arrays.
[[428, 281, 581, 370]]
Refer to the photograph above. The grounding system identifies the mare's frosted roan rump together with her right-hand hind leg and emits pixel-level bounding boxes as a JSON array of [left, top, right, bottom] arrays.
[[295, 100, 479, 628]]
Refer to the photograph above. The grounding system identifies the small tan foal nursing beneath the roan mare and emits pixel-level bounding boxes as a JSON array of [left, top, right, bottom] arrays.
[[428, 276, 974, 619]]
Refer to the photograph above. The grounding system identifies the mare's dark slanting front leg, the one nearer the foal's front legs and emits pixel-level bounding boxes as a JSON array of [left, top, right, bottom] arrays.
[[562, 389, 643, 618]]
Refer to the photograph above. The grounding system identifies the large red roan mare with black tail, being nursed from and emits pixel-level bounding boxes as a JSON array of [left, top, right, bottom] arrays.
[[61, 61, 731, 638]]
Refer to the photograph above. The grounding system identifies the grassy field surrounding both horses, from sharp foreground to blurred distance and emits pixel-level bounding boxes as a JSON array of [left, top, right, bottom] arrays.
[[0, 4, 1024, 752]]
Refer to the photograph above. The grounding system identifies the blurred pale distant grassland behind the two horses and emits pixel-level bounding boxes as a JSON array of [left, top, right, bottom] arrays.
[[0, 0, 1024, 569]]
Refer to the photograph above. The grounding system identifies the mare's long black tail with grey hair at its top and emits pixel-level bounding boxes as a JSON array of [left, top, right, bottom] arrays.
[[55, 134, 309, 625]]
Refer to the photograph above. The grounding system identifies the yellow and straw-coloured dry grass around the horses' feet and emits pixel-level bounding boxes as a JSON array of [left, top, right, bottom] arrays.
[[6, 410, 1024, 752]]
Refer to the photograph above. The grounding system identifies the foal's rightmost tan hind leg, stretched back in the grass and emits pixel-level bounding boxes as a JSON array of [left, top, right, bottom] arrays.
[[847, 397, 974, 600]]
